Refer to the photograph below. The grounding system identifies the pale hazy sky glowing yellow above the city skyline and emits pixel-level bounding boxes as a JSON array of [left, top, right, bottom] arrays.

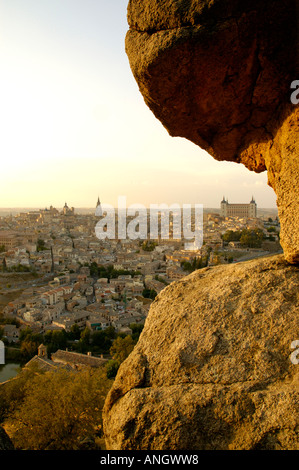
[[0, 0, 276, 207]]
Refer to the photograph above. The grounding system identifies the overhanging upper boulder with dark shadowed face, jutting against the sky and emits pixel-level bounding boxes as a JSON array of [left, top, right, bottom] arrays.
[[126, 0, 299, 263]]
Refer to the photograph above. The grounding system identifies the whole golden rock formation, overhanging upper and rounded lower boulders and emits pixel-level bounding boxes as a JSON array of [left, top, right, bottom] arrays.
[[103, 0, 299, 450]]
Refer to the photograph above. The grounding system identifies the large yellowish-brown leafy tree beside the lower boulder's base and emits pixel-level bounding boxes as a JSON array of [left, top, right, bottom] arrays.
[[5, 368, 111, 450]]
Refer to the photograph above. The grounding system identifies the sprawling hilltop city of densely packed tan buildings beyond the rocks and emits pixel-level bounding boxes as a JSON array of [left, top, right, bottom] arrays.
[[0, 197, 281, 343]]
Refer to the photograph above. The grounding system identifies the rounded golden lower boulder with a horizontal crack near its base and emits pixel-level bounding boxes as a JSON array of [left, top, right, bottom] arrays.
[[104, 255, 299, 450]]
